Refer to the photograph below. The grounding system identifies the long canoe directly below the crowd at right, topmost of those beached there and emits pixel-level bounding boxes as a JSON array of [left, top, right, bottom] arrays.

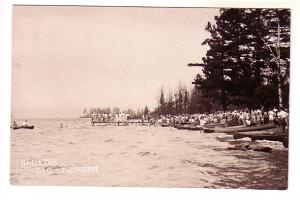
[[203, 123, 275, 133]]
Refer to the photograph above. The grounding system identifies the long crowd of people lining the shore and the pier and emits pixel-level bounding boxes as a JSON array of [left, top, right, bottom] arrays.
[[92, 108, 289, 132]]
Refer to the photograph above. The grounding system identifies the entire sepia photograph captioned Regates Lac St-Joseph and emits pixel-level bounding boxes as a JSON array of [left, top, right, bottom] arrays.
[[10, 5, 295, 190]]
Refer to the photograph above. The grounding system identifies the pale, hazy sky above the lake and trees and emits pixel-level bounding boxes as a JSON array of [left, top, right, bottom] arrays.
[[12, 6, 219, 118]]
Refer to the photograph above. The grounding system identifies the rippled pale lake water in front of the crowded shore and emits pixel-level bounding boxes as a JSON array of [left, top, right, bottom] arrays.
[[11, 119, 288, 189]]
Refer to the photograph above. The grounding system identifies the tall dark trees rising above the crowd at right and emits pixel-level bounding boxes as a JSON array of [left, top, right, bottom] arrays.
[[188, 9, 290, 110]]
